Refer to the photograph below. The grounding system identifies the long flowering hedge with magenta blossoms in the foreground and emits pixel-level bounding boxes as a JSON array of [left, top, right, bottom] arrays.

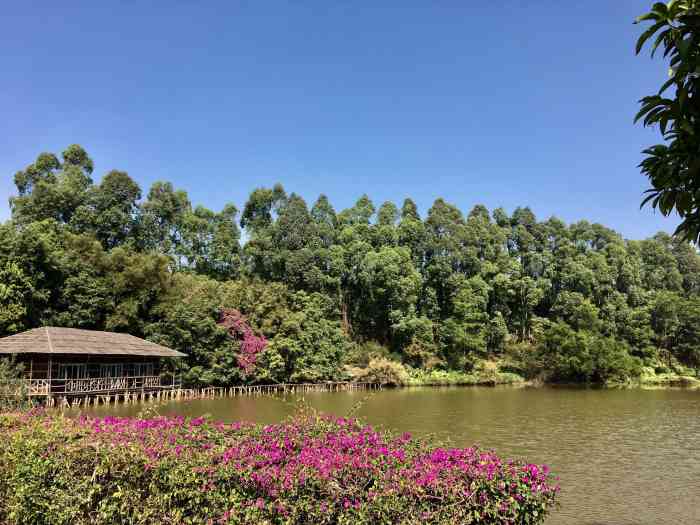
[[0, 413, 559, 525]]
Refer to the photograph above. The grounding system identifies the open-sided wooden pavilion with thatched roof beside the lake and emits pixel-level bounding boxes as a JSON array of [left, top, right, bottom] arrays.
[[0, 327, 185, 397]]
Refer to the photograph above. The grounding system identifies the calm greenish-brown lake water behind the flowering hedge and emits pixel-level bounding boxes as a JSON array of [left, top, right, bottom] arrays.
[[82, 387, 700, 525]]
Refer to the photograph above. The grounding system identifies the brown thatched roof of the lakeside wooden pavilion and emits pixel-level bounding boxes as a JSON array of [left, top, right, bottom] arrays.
[[0, 327, 185, 357]]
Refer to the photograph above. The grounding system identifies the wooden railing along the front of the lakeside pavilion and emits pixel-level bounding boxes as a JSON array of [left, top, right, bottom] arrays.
[[27, 376, 175, 396]]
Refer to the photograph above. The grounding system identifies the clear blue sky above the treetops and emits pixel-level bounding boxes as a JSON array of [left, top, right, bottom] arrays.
[[0, 0, 678, 238]]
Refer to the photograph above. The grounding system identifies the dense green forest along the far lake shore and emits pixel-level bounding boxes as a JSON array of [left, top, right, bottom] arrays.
[[0, 145, 700, 385]]
